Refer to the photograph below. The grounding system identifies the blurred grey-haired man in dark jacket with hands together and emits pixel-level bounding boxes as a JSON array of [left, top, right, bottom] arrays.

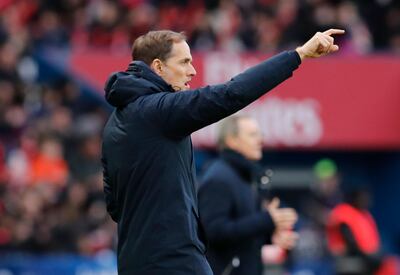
[[199, 115, 297, 275]]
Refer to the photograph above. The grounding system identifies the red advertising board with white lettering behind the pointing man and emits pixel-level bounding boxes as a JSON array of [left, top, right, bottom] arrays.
[[70, 52, 400, 150]]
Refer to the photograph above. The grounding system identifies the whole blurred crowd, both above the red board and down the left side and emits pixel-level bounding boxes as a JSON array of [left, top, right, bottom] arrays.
[[0, 0, 400, 254]]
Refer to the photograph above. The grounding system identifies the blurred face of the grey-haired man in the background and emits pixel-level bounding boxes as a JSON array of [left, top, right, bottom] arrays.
[[228, 117, 262, 161]]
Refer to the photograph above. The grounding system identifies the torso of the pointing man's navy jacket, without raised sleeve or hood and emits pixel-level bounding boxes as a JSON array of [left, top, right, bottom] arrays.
[[103, 63, 208, 274]]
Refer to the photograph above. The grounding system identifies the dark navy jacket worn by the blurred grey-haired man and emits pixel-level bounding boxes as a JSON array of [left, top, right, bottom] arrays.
[[199, 150, 275, 275]]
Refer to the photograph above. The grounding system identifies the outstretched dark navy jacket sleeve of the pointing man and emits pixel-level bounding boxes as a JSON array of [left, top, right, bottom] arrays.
[[139, 51, 301, 137]]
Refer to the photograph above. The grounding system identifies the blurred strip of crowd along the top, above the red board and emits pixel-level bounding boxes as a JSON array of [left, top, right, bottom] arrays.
[[0, 0, 400, 54]]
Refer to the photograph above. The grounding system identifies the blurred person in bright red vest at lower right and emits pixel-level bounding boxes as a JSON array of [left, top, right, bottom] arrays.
[[327, 187, 382, 275]]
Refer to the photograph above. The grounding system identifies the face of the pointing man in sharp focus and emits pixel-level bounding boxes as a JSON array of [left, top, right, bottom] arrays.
[[158, 41, 196, 91]]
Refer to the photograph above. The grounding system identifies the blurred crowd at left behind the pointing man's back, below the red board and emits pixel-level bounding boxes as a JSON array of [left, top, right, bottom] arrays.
[[0, 71, 115, 255]]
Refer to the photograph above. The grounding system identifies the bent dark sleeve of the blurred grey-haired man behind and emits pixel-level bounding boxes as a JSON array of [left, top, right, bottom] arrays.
[[199, 177, 275, 243]]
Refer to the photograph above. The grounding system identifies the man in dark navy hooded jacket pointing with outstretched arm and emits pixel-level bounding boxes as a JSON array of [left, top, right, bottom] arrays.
[[102, 29, 343, 275]]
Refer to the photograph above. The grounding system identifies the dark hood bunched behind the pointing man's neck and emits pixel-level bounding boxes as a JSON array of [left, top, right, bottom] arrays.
[[104, 61, 174, 107]]
